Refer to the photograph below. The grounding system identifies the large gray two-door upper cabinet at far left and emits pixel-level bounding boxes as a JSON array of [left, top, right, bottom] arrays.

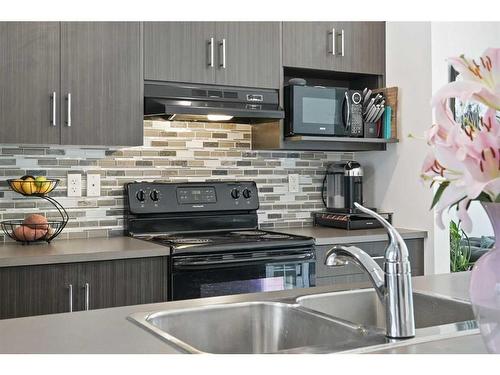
[[0, 22, 143, 146]]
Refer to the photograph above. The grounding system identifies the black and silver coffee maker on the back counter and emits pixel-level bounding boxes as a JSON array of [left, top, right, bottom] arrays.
[[322, 161, 363, 213]]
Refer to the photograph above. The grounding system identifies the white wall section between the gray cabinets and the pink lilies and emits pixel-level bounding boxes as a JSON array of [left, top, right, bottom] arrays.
[[356, 22, 440, 273]]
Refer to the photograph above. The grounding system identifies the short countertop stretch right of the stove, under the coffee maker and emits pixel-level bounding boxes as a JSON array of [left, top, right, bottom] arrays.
[[277, 227, 427, 245]]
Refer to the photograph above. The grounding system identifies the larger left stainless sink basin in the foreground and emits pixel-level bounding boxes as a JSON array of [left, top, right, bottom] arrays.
[[130, 302, 387, 353]]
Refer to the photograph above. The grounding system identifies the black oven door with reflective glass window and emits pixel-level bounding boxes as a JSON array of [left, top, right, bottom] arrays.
[[170, 248, 316, 300]]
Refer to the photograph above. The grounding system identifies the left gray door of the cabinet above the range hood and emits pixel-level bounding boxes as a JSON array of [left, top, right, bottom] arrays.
[[144, 22, 216, 84]]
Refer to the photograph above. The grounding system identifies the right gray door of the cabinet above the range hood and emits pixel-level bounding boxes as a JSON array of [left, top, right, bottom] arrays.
[[216, 22, 281, 88]]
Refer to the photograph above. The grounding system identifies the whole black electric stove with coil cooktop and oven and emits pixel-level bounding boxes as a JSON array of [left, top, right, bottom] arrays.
[[127, 181, 315, 300]]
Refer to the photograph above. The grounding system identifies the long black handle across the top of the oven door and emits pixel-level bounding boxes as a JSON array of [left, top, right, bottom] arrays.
[[173, 251, 316, 269]]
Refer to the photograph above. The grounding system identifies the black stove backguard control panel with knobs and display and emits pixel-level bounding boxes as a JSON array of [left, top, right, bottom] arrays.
[[126, 181, 259, 214]]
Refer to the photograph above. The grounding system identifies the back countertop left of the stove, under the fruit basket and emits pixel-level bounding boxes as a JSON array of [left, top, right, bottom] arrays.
[[0, 237, 170, 267]]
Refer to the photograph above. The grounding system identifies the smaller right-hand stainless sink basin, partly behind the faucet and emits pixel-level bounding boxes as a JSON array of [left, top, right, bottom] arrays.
[[297, 289, 474, 329]]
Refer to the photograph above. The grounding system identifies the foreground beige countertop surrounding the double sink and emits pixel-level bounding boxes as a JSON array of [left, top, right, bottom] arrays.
[[0, 272, 486, 353]]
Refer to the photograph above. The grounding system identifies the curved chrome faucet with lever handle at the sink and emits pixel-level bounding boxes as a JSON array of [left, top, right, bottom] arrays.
[[325, 203, 415, 339]]
